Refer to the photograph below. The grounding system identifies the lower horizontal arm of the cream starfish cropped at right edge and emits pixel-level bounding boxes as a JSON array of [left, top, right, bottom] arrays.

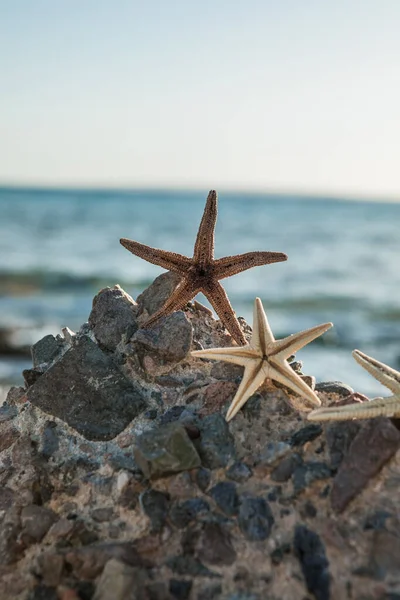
[[307, 396, 400, 421]]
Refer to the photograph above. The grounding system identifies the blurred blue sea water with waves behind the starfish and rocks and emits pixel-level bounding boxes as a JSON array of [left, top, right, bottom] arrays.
[[0, 188, 400, 395]]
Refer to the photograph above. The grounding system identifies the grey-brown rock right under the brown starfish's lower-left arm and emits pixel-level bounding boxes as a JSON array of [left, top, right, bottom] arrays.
[[132, 311, 193, 368]]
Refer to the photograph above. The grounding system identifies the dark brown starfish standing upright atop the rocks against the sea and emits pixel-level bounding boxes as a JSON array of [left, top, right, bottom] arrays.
[[120, 190, 287, 344]]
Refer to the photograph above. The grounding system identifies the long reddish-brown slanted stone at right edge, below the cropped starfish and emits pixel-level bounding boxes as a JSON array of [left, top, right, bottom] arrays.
[[331, 417, 400, 512]]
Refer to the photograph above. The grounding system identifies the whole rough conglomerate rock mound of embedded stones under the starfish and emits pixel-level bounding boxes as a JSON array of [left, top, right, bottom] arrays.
[[0, 273, 400, 600]]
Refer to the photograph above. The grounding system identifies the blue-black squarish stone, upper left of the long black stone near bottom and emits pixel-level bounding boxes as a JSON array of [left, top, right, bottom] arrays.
[[238, 495, 274, 542]]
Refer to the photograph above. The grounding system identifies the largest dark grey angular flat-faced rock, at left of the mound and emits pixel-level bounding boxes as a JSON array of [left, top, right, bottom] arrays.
[[27, 336, 146, 440]]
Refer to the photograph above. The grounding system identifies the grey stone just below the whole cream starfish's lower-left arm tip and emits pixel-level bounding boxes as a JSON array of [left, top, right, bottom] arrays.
[[195, 414, 236, 469]]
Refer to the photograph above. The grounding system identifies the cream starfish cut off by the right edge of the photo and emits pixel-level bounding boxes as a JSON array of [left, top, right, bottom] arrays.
[[307, 350, 400, 421]]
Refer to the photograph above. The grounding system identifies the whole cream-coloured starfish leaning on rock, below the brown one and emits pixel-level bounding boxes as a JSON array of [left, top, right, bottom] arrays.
[[192, 298, 332, 421]]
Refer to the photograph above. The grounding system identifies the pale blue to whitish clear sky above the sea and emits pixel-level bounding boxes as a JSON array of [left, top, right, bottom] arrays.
[[0, 0, 400, 199]]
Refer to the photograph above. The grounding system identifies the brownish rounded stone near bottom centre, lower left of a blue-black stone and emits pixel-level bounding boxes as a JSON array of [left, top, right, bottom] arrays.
[[197, 522, 236, 566]]
